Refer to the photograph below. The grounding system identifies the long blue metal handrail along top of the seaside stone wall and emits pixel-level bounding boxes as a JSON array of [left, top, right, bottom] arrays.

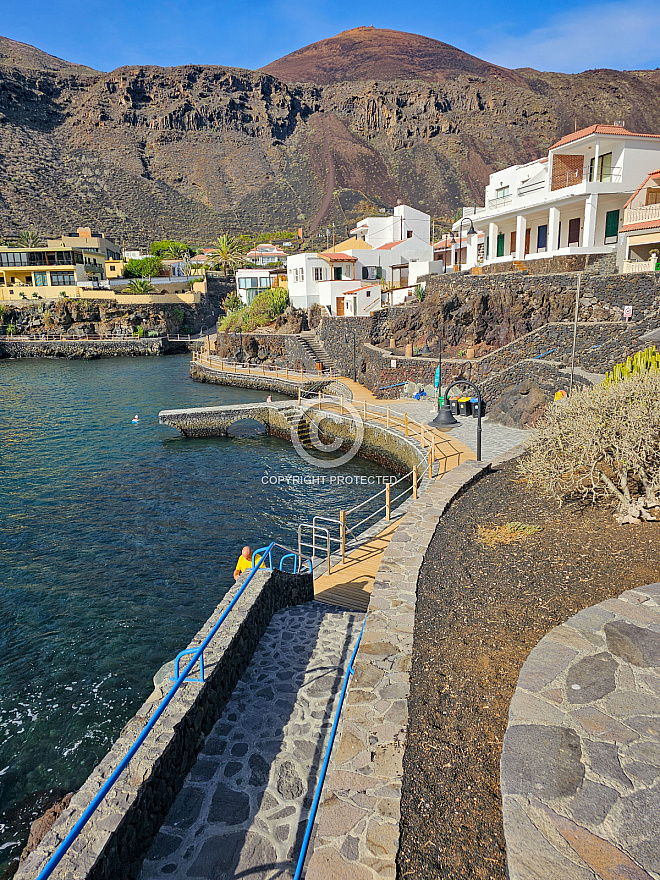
[[37, 541, 312, 880]]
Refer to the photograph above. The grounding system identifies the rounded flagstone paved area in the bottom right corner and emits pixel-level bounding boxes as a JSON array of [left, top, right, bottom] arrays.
[[501, 584, 660, 880]]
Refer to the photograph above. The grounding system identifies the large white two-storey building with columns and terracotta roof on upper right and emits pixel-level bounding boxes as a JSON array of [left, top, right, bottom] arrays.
[[453, 125, 660, 268]]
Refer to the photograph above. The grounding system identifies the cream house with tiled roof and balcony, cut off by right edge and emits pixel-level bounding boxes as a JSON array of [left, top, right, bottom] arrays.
[[619, 168, 660, 272]]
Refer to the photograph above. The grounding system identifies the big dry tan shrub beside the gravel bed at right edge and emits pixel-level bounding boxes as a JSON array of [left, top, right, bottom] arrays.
[[520, 372, 660, 523]]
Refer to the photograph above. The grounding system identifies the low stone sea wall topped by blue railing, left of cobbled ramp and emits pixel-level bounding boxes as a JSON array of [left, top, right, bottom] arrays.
[[16, 571, 314, 880]]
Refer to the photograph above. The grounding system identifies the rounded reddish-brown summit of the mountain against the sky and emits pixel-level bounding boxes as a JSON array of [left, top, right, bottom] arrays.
[[261, 27, 521, 85]]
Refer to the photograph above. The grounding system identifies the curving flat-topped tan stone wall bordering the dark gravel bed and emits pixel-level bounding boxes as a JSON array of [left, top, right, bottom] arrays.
[[305, 453, 500, 880]]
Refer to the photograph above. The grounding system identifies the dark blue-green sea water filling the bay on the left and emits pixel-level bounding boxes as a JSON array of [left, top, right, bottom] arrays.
[[0, 356, 392, 875]]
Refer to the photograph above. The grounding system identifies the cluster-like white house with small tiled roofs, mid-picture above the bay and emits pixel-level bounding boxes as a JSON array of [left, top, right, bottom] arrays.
[[287, 205, 433, 315]]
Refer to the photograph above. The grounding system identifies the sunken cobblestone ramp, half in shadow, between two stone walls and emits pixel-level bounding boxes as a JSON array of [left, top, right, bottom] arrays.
[[141, 602, 363, 880]]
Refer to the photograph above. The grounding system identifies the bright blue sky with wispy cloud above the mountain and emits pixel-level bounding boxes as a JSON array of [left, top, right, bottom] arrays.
[[0, 0, 660, 73]]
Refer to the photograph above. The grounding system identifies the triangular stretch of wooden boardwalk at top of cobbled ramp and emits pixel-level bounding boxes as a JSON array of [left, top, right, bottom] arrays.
[[314, 520, 398, 611]]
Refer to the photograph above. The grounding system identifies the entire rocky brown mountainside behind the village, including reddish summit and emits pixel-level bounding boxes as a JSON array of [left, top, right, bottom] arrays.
[[0, 28, 660, 245]]
